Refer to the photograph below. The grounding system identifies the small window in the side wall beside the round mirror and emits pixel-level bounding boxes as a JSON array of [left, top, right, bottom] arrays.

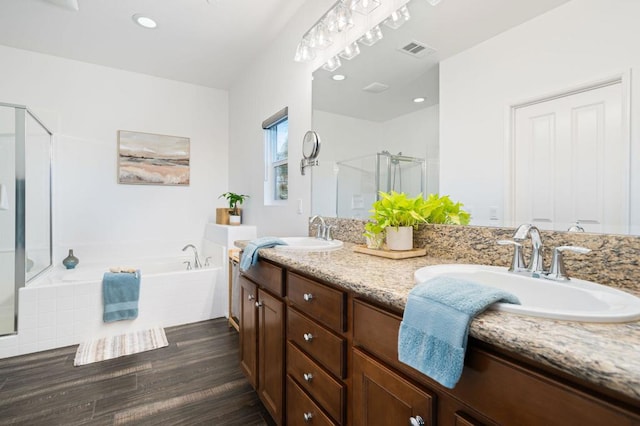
[[262, 108, 289, 204]]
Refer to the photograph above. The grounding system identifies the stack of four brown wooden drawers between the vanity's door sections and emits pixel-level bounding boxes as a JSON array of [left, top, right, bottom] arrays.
[[287, 272, 348, 425]]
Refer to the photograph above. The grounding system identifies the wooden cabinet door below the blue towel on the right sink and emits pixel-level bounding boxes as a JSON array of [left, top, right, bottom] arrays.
[[353, 349, 433, 426]]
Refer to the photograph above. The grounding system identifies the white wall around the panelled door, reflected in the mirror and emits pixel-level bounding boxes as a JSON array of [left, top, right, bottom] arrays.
[[440, 0, 640, 233]]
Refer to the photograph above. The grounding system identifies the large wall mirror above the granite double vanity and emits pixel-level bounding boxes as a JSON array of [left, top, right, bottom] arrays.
[[312, 0, 640, 235]]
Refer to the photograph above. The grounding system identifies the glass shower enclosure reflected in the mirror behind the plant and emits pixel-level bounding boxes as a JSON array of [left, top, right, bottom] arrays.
[[336, 151, 427, 219]]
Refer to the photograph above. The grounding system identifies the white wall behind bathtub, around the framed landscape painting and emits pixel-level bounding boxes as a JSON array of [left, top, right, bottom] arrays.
[[0, 46, 229, 263]]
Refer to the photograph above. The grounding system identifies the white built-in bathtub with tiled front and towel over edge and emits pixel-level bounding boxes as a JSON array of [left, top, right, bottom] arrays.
[[0, 258, 228, 358]]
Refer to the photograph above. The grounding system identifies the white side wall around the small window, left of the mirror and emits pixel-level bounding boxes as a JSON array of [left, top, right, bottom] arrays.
[[228, 0, 332, 236]]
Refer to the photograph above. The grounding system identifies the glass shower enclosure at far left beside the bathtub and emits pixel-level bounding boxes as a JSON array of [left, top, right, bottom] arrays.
[[0, 103, 52, 336]]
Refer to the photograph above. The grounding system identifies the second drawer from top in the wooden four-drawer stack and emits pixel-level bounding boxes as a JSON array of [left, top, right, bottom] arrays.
[[287, 308, 346, 379]]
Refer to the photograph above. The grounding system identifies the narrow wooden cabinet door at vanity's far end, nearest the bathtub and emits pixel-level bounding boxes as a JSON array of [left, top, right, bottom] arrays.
[[239, 276, 258, 388]]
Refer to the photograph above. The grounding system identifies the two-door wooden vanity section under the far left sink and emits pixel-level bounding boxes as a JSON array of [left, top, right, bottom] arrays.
[[240, 261, 285, 425]]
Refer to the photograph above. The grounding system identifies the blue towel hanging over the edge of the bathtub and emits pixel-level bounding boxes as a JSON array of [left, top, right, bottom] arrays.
[[102, 270, 140, 322]]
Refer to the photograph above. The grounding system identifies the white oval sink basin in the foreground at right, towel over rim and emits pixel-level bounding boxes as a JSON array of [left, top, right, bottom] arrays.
[[414, 264, 640, 322]]
